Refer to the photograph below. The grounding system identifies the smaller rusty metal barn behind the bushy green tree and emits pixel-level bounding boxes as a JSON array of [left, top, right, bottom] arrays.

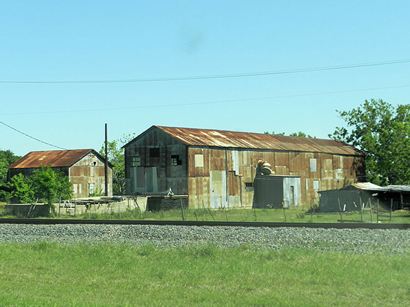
[[9, 149, 112, 198]]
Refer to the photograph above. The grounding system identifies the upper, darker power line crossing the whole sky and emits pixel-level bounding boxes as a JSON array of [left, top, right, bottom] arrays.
[[0, 59, 410, 84]]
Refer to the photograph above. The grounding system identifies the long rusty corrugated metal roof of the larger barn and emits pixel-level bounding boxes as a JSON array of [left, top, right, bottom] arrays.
[[155, 126, 363, 155]]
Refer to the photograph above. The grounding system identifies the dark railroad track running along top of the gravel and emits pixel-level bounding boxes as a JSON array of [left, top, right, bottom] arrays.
[[0, 218, 410, 230]]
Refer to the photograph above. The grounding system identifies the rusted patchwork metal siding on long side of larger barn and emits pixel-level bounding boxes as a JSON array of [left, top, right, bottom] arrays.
[[188, 147, 363, 208]]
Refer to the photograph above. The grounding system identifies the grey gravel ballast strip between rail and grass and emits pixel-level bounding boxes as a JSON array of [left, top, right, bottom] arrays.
[[0, 224, 410, 253]]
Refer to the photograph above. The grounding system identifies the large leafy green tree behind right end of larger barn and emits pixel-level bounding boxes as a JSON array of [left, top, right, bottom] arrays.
[[329, 99, 410, 185]]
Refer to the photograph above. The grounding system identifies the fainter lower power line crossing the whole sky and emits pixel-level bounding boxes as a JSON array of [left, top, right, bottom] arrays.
[[2, 84, 410, 116]]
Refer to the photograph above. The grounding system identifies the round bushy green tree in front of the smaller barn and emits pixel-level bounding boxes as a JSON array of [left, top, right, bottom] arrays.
[[29, 167, 72, 206]]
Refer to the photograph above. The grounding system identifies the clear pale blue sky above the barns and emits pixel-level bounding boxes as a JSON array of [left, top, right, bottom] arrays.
[[0, 0, 410, 154]]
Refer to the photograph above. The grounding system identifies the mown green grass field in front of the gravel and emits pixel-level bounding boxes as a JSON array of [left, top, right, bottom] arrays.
[[0, 243, 410, 306]]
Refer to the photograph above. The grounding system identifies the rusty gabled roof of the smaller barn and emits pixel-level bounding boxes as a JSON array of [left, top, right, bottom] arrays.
[[10, 149, 111, 169]]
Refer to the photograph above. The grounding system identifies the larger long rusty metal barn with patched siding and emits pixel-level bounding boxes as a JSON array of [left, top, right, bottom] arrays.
[[124, 126, 364, 208]]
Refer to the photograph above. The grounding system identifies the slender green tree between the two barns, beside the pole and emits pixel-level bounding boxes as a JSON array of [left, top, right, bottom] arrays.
[[99, 134, 134, 195]]
